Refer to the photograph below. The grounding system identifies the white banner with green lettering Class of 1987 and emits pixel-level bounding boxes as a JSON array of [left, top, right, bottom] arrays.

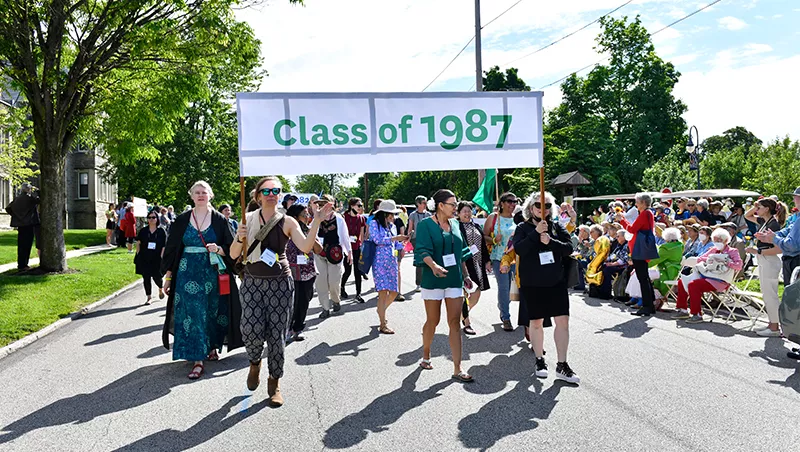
[[236, 92, 543, 176]]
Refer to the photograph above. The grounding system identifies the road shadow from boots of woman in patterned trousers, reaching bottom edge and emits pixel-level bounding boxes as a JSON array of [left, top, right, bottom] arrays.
[[111, 396, 269, 452]]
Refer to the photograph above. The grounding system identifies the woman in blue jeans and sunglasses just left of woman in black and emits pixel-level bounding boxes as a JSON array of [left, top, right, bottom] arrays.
[[483, 192, 519, 331]]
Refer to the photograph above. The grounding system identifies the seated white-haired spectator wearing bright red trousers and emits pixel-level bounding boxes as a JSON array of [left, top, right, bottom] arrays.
[[672, 228, 742, 323]]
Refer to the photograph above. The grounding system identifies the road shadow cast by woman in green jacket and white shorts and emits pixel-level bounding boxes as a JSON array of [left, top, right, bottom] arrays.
[[322, 367, 454, 449]]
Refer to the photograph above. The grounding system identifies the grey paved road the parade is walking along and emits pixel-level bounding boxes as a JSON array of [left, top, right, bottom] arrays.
[[0, 259, 800, 452]]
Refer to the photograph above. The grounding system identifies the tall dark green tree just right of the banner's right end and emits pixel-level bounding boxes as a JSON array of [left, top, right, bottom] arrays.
[[545, 16, 686, 192]]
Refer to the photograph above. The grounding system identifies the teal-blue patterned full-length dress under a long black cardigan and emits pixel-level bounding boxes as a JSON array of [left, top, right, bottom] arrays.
[[172, 222, 228, 361]]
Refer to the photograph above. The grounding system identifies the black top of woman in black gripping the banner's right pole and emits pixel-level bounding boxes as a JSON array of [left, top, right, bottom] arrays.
[[512, 221, 572, 287]]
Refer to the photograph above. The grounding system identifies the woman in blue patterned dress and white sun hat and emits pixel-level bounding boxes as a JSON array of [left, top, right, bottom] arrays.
[[369, 199, 408, 334]]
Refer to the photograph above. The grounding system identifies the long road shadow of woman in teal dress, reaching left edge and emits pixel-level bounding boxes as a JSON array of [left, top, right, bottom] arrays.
[[0, 355, 247, 444]]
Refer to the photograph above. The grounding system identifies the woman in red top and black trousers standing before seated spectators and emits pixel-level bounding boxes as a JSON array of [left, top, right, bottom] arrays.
[[616, 193, 658, 316]]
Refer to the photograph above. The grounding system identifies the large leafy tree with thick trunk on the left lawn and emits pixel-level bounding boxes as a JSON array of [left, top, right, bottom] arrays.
[[0, 0, 298, 271]]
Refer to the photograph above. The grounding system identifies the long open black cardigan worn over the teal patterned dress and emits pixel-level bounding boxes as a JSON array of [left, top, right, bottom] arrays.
[[161, 210, 244, 351]]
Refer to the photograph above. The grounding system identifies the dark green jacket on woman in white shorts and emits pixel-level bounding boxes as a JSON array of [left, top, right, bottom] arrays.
[[414, 217, 472, 289]]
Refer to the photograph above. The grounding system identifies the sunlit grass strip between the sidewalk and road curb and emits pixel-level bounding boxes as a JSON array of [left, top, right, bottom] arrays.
[[0, 249, 140, 347]]
